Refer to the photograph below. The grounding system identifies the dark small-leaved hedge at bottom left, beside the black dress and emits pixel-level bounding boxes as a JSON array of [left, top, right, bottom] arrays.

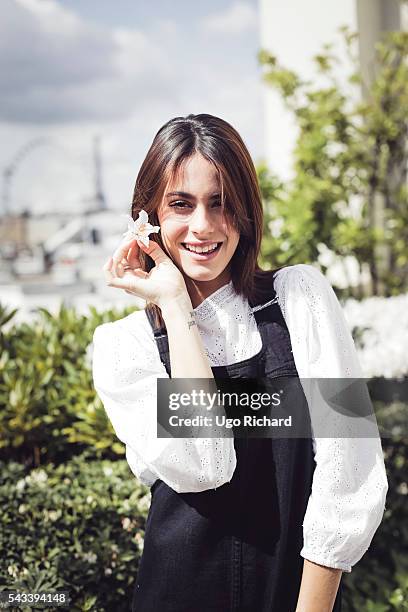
[[0, 453, 150, 612]]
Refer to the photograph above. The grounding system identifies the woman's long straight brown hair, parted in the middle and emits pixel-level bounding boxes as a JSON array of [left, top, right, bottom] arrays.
[[132, 114, 280, 327]]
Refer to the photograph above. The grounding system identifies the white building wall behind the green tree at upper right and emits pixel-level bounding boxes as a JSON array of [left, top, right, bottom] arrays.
[[259, 0, 408, 180]]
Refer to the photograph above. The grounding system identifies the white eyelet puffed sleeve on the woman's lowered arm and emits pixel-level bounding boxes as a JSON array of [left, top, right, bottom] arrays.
[[275, 264, 388, 572]]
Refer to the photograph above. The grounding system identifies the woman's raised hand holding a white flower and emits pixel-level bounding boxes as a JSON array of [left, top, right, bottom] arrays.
[[103, 238, 189, 307]]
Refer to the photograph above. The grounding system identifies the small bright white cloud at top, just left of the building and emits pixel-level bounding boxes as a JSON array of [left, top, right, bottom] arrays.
[[202, 2, 258, 34]]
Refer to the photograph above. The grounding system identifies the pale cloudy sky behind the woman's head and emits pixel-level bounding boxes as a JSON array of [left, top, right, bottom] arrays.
[[0, 0, 264, 213]]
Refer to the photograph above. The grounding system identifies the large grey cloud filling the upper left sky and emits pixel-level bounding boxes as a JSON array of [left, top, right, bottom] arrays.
[[0, 0, 178, 124]]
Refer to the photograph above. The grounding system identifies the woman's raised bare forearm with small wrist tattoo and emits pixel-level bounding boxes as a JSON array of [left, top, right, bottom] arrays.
[[161, 294, 214, 378]]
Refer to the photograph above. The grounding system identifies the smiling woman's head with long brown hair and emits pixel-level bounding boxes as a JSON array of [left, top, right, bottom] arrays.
[[132, 115, 264, 324]]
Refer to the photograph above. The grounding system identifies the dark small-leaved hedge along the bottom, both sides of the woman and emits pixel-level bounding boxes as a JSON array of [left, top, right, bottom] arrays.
[[0, 440, 408, 612]]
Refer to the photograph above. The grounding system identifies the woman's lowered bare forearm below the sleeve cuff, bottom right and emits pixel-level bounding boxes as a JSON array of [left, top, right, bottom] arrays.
[[296, 559, 342, 612]]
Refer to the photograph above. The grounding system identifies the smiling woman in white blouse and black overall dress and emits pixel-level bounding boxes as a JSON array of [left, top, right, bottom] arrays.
[[93, 114, 387, 612]]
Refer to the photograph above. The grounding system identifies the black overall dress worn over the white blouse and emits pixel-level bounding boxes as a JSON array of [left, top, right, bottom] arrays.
[[132, 293, 341, 612]]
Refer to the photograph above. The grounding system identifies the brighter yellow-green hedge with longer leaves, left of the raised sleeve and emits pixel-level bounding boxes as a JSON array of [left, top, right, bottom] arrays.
[[0, 306, 135, 466]]
